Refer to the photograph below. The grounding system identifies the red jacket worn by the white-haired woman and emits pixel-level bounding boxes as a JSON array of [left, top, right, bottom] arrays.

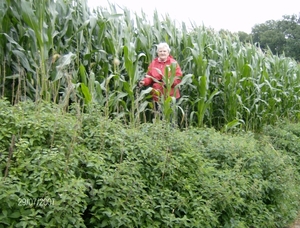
[[144, 55, 182, 101]]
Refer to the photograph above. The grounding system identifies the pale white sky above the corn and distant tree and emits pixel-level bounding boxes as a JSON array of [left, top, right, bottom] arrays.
[[87, 0, 300, 33]]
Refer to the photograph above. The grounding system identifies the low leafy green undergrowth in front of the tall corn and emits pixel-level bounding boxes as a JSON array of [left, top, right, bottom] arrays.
[[0, 100, 300, 228]]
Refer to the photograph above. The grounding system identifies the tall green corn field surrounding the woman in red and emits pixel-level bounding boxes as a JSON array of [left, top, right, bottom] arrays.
[[0, 0, 300, 131]]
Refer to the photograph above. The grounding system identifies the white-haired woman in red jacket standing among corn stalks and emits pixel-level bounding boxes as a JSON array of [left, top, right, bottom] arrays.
[[139, 43, 182, 102]]
